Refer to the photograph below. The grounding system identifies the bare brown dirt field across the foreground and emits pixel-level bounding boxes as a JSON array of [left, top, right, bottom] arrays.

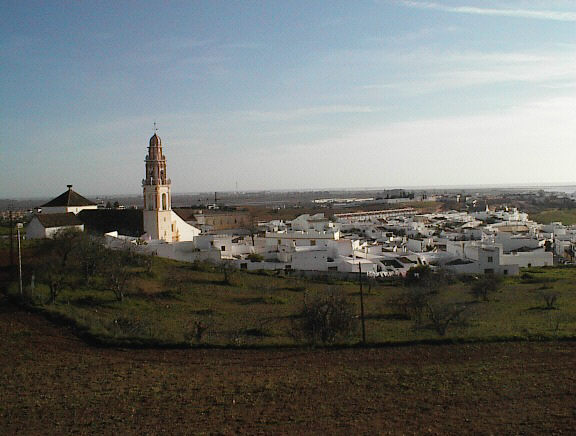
[[0, 303, 576, 434]]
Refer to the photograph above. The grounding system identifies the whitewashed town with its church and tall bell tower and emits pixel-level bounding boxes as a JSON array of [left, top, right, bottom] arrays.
[[14, 133, 576, 277]]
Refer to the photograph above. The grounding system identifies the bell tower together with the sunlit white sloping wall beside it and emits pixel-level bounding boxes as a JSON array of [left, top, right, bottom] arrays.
[[142, 132, 200, 242]]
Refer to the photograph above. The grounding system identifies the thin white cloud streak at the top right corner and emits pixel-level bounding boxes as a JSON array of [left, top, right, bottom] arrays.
[[402, 0, 576, 21]]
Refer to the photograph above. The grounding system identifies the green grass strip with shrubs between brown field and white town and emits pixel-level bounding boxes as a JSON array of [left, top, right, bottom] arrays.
[[4, 252, 576, 346]]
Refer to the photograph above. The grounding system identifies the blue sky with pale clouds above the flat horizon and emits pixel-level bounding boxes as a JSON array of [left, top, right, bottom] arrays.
[[0, 0, 576, 198]]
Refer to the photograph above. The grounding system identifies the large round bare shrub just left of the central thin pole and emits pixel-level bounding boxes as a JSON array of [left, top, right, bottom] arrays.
[[292, 290, 357, 345]]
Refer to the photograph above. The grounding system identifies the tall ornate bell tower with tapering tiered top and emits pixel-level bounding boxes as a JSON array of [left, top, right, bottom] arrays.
[[142, 123, 174, 242]]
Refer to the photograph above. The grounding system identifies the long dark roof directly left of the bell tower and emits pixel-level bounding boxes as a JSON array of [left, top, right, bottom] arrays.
[[78, 209, 144, 237]]
